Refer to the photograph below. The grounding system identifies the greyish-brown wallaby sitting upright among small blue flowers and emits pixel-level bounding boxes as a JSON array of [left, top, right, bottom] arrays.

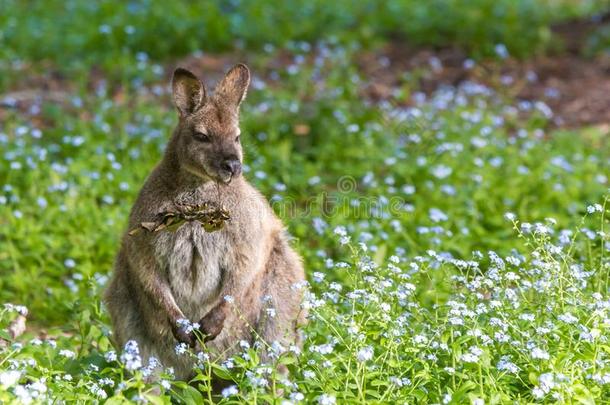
[[105, 64, 305, 379]]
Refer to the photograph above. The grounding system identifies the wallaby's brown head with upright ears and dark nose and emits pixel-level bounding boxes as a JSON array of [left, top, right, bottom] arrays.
[[172, 64, 250, 183]]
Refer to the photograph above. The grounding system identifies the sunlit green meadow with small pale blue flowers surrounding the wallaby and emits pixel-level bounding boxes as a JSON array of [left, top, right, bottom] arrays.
[[0, 2, 610, 404]]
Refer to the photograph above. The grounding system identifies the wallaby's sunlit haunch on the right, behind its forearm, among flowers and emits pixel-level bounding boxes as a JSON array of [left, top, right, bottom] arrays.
[[257, 234, 306, 361]]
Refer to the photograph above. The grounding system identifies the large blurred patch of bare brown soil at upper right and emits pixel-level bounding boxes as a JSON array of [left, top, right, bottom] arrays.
[[360, 14, 610, 130]]
